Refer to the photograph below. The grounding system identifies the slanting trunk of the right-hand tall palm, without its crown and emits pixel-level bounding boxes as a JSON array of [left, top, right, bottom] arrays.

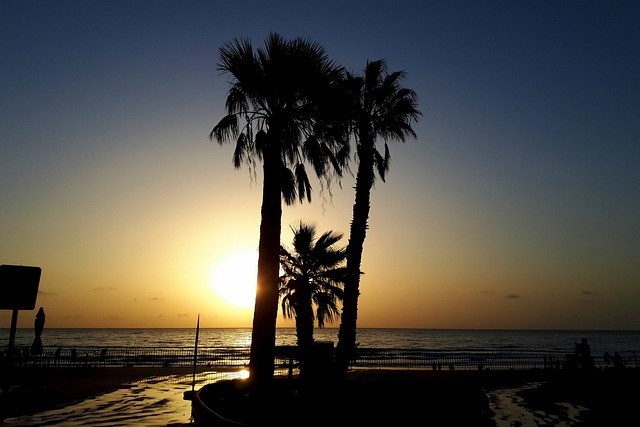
[[335, 141, 374, 379]]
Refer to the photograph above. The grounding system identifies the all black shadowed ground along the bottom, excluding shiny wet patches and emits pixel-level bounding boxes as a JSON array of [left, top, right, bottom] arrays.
[[0, 367, 640, 427]]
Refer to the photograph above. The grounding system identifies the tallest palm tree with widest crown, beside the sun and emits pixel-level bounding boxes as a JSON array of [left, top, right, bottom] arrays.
[[210, 33, 344, 393]]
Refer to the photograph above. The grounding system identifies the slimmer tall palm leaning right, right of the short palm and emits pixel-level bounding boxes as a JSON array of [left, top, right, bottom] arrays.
[[336, 60, 422, 378]]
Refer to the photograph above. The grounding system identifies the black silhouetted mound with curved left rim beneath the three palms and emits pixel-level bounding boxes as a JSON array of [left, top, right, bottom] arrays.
[[199, 370, 504, 427]]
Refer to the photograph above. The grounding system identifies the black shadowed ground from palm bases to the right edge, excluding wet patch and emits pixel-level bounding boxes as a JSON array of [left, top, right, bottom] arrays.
[[201, 368, 640, 427]]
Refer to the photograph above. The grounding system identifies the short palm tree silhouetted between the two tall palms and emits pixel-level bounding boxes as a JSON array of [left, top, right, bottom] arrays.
[[280, 222, 346, 381]]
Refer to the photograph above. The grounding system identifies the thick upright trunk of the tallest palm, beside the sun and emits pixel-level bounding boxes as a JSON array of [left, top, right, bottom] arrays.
[[249, 143, 282, 396]]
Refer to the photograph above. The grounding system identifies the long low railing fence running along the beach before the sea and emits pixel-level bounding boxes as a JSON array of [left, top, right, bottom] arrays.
[[0, 346, 638, 371]]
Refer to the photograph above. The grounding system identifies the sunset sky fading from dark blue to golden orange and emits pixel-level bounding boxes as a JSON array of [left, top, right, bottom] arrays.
[[0, 0, 640, 329]]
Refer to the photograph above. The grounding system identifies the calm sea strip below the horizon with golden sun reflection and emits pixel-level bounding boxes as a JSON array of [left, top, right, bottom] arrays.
[[5, 327, 640, 355]]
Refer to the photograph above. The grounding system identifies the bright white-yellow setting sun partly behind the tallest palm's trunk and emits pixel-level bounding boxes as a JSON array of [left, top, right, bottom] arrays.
[[211, 249, 258, 308]]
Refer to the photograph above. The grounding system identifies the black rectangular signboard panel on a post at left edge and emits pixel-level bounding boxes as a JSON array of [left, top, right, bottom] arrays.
[[0, 264, 42, 310]]
